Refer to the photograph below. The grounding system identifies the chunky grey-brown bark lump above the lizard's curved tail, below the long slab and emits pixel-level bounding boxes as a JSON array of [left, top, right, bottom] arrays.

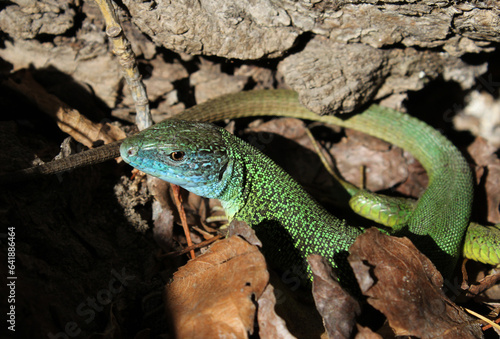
[[278, 37, 487, 113]]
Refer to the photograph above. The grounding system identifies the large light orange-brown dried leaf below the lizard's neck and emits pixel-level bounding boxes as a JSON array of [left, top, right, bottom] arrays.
[[165, 237, 269, 338]]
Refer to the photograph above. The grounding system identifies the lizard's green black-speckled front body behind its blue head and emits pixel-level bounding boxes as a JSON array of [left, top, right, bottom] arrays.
[[218, 131, 361, 286]]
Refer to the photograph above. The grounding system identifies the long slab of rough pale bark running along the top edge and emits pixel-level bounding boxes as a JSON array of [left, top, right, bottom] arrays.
[[124, 0, 500, 59]]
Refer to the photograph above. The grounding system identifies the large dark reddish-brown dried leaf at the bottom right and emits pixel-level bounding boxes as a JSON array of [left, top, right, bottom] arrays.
[[349, 228, 482, 338]]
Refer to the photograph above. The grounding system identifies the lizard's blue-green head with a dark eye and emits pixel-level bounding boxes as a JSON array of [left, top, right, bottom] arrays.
[[120, 120, 232, 198]]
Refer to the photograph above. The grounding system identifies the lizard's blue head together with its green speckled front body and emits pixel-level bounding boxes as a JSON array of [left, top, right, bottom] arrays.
[[120, 120, 362, 280]]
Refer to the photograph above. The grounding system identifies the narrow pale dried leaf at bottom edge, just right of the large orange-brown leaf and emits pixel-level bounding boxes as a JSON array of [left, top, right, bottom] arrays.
[[257, 285, 295, 339]]
